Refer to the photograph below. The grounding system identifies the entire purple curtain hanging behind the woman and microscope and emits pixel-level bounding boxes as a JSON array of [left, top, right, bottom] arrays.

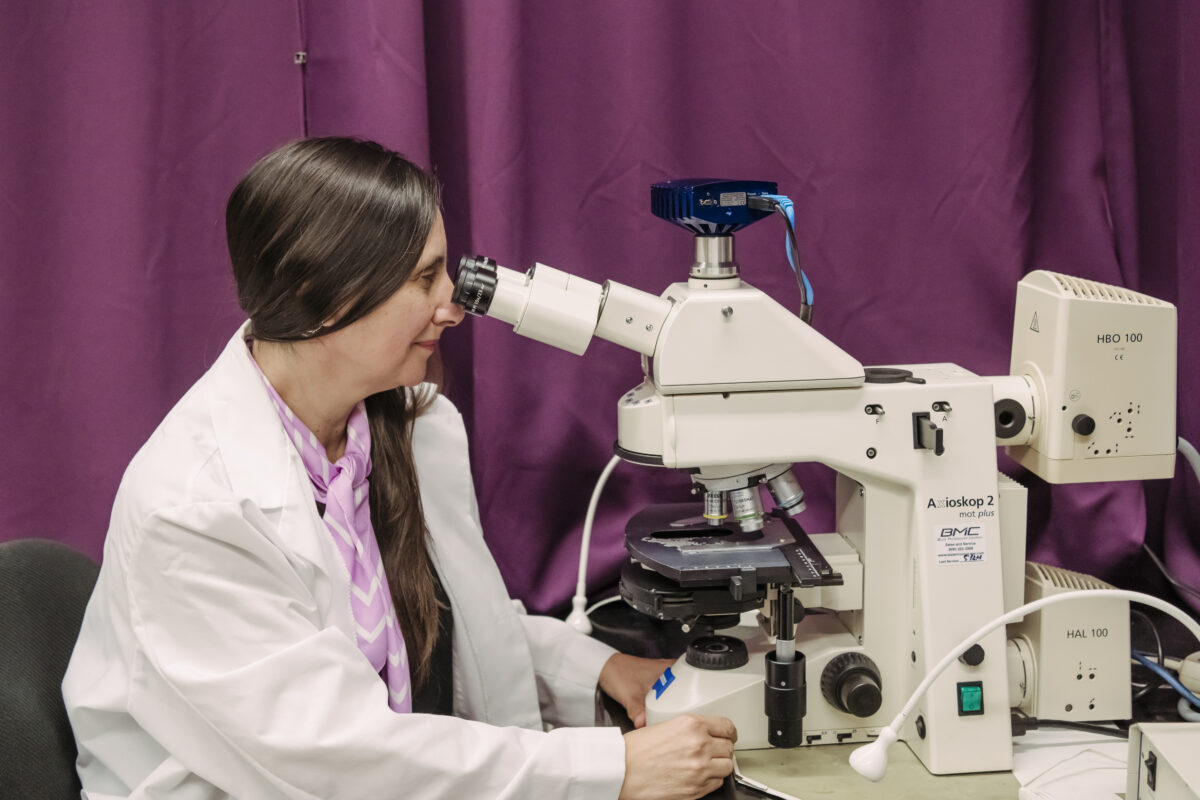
[[0, 0, 1200, 609]]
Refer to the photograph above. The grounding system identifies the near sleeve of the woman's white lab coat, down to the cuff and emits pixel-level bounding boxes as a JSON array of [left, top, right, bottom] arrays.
[[126, 501, 624, 800]]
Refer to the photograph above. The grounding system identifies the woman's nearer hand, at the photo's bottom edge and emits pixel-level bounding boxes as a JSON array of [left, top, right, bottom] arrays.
[[619, 714, 738, 800]]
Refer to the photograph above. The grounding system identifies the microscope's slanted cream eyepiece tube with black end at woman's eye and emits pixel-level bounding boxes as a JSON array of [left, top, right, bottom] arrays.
[[452, 255, 671, 355]]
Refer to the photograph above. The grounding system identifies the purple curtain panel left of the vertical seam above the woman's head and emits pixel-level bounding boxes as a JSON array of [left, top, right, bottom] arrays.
[[0, 0, 301, 557]]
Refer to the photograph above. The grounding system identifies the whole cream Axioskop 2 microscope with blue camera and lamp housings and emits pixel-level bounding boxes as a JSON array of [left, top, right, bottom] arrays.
[[455, 179, 1176, 774]]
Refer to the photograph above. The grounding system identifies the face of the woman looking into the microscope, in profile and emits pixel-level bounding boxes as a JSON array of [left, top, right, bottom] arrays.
[[319, 213, 463, 397]]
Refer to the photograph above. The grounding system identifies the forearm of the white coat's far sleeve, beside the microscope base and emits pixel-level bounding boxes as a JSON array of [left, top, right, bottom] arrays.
[[521, 615, 617, 726]]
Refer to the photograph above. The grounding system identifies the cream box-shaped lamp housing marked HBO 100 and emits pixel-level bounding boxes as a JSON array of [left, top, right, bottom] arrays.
[[1008, 270, 1177, 483]]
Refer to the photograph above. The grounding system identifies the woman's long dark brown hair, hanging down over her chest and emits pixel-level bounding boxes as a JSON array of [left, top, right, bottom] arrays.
[[226, 138, 440, 685]]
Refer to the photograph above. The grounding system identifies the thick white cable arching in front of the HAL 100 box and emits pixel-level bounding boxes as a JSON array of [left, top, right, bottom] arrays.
[[850, 589, 1200, 781]]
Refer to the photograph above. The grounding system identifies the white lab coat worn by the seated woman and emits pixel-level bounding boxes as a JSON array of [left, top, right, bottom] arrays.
[[62, 331, 624, 800]]
